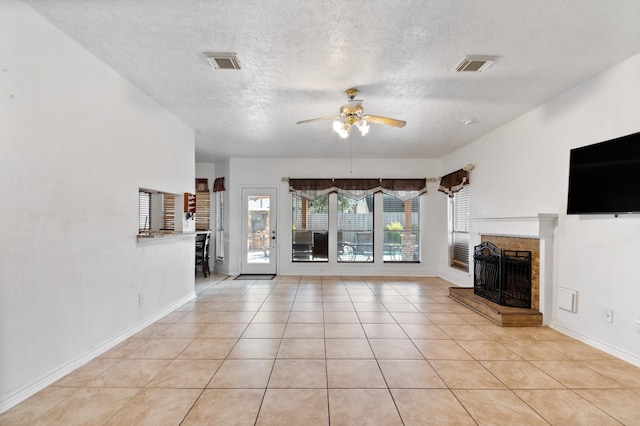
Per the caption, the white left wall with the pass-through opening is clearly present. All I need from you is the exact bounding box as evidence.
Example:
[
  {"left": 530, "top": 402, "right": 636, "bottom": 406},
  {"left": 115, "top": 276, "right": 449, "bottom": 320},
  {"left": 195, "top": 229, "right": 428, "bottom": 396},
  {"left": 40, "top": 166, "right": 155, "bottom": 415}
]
[{"left": 0, "top": 0, "right": 195, "bottom": 411}]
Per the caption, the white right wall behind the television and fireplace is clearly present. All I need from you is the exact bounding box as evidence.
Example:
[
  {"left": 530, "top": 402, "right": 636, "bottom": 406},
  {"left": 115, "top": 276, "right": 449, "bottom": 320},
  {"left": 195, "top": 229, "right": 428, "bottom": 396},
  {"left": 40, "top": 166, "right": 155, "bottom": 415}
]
[{"left": 441, "top": 55, "right": 640, "bottom": 365}]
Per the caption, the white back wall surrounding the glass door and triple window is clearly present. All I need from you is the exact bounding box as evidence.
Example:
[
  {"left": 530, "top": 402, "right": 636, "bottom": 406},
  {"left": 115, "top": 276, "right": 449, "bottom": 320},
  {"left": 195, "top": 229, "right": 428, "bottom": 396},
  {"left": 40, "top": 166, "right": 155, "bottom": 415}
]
[{"left": 225, "top": 156, "right": 446, "bottom": 276}]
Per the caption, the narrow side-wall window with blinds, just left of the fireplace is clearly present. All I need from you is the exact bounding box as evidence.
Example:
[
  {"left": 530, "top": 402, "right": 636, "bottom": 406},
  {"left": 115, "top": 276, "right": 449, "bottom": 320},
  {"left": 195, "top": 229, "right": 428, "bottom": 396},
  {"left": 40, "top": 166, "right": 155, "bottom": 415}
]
[{"left": 448, "top": 185, "right": 470, "bottom": 272}]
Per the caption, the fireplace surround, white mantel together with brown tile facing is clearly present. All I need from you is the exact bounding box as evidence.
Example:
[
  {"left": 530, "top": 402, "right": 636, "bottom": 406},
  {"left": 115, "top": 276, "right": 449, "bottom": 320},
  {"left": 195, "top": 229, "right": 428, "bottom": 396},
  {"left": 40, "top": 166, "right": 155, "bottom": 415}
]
[{"left": 469, "top": 213, "right": 558, "bottom": 324}]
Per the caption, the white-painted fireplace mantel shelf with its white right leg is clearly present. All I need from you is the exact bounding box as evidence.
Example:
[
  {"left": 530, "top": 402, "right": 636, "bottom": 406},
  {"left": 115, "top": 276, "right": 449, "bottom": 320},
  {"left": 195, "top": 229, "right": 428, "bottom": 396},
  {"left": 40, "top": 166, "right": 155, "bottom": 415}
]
[{"left": 469, "top": 213, "right": 558, "bottom": 324}]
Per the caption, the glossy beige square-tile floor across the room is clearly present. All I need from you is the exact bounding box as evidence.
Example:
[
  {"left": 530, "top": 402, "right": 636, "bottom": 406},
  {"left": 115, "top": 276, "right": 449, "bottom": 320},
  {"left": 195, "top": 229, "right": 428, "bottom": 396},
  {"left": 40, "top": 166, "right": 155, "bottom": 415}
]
[{"left": 0, "top": 277, "right": 640, "bottom": 426}]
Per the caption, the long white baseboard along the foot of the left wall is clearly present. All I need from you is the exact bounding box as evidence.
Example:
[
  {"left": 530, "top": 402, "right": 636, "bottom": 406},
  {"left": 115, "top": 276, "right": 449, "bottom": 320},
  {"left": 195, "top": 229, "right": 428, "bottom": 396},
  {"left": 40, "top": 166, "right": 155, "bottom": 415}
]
[{"left": 0, "top": 292, "right": 196, "bottom": 414}]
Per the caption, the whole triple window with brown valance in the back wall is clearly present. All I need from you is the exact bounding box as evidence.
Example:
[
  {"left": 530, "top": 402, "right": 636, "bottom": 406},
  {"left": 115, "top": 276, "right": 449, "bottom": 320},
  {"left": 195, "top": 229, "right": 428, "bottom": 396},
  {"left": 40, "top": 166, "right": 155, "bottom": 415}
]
[{"left": 288, "top": 178, "right": 427, "bottom": 263}]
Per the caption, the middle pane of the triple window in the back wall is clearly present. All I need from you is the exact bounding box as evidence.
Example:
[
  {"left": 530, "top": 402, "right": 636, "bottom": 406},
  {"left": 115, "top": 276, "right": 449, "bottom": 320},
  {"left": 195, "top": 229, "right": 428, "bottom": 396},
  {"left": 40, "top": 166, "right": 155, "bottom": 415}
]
[{"left": 338, "top": 194, "right": 373, "bottom": 262}]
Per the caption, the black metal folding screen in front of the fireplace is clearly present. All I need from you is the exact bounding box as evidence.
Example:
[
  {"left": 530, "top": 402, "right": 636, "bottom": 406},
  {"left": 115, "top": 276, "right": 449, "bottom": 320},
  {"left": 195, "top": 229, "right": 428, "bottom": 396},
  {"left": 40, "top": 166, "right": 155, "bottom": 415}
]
[{"left": 473, "top": 242, "right": 531, "bottom": 309}]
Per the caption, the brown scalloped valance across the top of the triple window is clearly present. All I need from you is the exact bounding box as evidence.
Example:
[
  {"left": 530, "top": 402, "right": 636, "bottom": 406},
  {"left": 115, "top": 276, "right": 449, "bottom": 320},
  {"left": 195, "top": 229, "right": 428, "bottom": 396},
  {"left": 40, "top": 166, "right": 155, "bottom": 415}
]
[{"left": 289, "top": 178, "right": 427, "bottom": 201}]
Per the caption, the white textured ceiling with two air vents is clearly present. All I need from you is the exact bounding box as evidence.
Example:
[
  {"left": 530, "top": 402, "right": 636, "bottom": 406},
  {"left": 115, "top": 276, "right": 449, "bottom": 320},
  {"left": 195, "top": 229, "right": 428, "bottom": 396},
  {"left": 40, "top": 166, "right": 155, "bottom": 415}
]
[{"left": 26, "top": 0, "right": 640, "bottom": 161}]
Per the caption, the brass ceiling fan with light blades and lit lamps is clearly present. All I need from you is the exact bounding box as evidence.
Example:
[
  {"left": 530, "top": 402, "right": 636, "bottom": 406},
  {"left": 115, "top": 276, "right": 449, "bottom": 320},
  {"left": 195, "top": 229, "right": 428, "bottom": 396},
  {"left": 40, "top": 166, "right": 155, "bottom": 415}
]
[{"left": 296, "top": 88, "right": 407, "bottom": 138}]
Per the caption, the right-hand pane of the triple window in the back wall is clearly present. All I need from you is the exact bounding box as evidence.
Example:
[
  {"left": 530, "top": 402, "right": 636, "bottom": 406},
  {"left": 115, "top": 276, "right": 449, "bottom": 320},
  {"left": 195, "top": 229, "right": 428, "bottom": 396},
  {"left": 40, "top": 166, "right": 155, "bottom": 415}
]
[{"left": 382, "top": 194, "right": 420, "bottom": 262}]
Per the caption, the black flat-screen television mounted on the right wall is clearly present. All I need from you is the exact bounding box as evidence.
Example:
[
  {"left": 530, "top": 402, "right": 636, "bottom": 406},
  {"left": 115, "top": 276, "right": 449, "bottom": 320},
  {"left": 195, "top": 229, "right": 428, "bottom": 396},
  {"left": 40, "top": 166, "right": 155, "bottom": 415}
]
[{"left": 567, "top": 132, "right": 640, "bottom": 214}]
